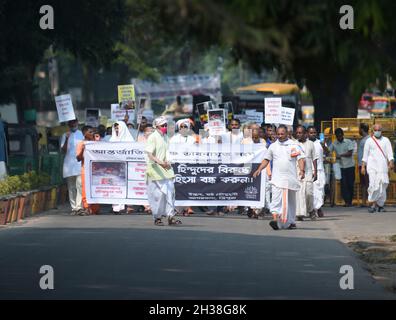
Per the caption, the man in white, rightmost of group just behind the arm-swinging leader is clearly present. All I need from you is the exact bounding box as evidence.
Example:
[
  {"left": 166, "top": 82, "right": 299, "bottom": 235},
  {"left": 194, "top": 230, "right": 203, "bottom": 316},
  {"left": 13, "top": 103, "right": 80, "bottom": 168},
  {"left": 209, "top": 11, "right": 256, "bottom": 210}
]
[{"left": 308, "top": 126, "right": 326, "bottom": 218}]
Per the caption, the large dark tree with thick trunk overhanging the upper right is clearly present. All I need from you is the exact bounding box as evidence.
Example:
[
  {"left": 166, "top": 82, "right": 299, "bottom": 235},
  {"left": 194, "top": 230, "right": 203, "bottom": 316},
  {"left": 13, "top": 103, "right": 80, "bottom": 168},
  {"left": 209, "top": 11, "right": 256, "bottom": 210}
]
[{"left": 154, "top": 0, "right": 396, "bottom": 124}]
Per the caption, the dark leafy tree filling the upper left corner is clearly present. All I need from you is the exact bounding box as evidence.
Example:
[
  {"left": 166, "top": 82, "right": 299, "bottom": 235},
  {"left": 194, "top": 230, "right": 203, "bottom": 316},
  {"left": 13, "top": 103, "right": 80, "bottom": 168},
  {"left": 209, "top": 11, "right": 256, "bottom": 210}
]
[{"left": 0, "top": 0, "right": 125, "bottom": 120}]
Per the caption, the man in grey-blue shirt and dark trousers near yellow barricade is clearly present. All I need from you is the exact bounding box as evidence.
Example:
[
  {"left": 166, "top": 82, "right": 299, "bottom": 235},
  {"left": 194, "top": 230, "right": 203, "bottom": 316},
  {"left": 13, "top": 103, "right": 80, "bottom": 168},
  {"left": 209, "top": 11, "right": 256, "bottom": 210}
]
[{"left": 328, "top": 128, "right": 355, "bottom": 207}]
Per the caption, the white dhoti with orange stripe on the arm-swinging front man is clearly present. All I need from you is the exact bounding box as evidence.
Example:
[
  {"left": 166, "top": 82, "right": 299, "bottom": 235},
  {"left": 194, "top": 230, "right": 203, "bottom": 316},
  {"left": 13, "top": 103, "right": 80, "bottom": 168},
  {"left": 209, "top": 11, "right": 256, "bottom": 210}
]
[{"left": 270, "top": 185, "right": 297, "bottom": 229}]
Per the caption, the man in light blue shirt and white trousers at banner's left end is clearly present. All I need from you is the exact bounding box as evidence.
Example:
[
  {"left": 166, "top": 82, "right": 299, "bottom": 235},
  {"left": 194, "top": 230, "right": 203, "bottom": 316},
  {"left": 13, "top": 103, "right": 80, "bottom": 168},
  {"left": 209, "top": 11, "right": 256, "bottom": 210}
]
[{"left": 61, "top": 119, "right": 84, "bottom": 215}]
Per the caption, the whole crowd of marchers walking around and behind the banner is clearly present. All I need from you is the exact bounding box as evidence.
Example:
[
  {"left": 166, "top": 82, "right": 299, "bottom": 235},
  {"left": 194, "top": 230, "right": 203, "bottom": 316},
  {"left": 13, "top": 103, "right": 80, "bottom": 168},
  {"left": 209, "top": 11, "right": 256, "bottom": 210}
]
[{"left": 61, "top": 116, "right": 393, "bottom": 230}]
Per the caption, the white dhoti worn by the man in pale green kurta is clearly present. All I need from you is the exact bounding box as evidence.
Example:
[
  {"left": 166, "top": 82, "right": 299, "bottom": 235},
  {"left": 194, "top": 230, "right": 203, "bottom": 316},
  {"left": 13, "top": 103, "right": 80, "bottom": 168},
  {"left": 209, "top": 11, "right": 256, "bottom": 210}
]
[{"left": 147, "top": 180, "right": 175, "bottom": 220}]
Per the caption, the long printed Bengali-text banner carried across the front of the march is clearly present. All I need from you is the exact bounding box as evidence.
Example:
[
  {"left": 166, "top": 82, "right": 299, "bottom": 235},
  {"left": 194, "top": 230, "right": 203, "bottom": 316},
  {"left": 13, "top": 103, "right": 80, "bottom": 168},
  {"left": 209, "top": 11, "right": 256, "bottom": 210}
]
[{"left": 84, "top": 142, "right": 265, "bottom": 207}]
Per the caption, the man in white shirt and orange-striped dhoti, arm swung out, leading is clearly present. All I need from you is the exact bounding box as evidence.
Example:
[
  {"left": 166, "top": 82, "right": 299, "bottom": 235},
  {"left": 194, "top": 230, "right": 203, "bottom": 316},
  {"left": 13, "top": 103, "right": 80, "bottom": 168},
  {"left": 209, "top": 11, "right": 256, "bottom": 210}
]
[{"left": 253, "top": 125, "right": 305, "bottom": 230}]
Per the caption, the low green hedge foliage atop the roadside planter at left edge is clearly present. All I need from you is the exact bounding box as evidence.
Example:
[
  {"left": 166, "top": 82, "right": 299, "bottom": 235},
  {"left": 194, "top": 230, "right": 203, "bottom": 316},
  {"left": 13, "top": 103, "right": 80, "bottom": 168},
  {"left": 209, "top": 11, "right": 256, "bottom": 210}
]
[{"left": 0, "top": 171, "right": 51, "bottom": 196}]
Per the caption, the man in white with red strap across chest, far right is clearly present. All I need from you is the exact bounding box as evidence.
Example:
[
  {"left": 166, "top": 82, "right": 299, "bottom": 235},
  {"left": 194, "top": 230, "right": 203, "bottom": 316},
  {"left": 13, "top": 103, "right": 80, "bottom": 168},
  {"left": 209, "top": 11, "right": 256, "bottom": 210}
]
[{"left": 361, "top": 124, "right": 394, "bottom": 213}]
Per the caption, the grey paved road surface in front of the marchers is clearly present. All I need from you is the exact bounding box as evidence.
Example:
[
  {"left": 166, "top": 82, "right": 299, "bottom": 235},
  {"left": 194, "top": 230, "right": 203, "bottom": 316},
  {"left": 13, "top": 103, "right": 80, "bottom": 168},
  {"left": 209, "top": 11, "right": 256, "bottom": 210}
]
[{"left": 0, "top": 209, "right": 396, "bottom": 299}]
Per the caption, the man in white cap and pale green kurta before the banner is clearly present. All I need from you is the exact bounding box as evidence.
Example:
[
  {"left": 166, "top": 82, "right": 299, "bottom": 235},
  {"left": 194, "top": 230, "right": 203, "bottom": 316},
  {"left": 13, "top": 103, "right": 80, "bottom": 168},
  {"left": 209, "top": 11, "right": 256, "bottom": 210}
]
[{"left": 145, "top": 116, "right": 181, "bottom": 226}]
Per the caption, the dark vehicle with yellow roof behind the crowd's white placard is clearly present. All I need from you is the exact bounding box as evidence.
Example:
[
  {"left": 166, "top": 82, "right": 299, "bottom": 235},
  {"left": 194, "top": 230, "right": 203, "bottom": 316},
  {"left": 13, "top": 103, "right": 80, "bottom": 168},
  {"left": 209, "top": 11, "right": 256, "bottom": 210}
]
[{"left": 223, "top": 83, "right": 302, "bottom": 124}]
